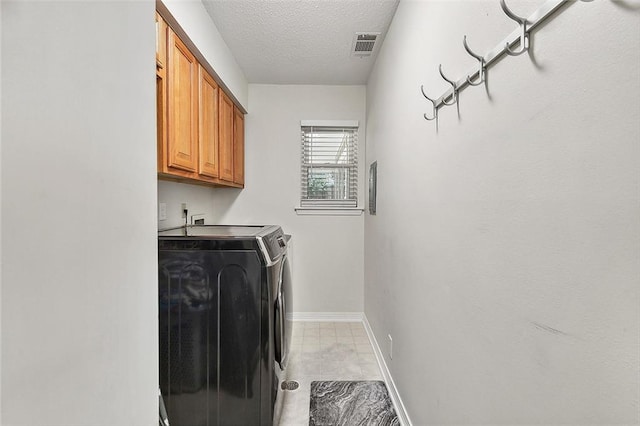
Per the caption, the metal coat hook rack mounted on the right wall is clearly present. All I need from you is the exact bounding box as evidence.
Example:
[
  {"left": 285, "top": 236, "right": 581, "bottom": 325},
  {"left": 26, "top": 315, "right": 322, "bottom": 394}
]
[{"left": 420, "top": 0, "right": 571, "bottom": 122}]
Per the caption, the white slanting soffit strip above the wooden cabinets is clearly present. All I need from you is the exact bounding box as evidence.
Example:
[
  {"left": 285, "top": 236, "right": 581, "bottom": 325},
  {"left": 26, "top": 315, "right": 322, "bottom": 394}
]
[{"left": 163, "top": 0, "right": 248, "bottom": 109}]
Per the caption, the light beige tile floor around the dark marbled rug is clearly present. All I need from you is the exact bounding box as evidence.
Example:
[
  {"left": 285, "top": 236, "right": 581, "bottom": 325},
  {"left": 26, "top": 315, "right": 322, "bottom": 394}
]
[{"left": 280, "top": 321, "right": 383, "bottom": 426}]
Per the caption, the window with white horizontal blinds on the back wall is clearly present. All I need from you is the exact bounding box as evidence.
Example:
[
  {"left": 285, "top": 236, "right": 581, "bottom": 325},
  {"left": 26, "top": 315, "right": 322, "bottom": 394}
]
[{"left": 300, "top": 121, "right": 358, "bottom": 208}]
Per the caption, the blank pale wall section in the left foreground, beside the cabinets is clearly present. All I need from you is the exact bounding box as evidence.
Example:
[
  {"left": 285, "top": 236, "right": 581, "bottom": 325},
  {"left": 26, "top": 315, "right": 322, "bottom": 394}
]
[{"left": 0, "top": 1, "right": 158, "bottom": 426}]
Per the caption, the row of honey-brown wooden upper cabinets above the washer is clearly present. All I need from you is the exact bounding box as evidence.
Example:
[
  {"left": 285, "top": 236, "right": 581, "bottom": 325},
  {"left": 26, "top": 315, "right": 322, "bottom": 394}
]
[{"left": 155, "top": 12, "right": 244, "bottom": 188}]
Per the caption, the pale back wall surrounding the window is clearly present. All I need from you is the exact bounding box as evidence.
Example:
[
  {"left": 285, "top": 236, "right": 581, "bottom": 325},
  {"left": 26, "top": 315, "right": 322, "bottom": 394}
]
[{"left": 214, "top": 84, "right": 366, "bottom": 312}]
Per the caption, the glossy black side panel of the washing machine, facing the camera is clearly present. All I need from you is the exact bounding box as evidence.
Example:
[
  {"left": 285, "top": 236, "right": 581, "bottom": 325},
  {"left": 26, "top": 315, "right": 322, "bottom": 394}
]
[{"left": 158, "top": 250, "right": 268, "bottom": 426}]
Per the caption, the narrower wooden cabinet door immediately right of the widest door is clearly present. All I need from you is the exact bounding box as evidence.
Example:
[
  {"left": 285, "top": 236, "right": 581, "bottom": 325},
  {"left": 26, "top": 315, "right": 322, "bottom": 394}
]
[{"left": 198, "top": 66, "right": 220, "bottom": 178}]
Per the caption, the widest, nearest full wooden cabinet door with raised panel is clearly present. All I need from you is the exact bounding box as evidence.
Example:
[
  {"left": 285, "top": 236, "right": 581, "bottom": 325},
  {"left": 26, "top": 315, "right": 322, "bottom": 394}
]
[{"left": 167, "top": 30, "right": 198, "bottom": 172}]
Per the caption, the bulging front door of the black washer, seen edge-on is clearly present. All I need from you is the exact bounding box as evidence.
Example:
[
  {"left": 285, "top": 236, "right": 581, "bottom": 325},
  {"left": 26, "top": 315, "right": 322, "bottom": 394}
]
[{"left": 274, "top": 252, "right": 292, "bottom": 370}]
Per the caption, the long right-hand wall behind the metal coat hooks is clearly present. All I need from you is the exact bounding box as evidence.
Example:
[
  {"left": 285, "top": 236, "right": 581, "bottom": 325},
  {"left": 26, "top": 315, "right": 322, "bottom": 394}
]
[{"left": 365, "top": 1, "right": 640, "bottom": 425}]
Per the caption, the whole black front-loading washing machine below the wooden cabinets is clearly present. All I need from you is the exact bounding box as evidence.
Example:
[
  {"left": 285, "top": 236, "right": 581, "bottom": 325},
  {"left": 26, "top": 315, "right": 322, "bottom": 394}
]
[{"left": 158, "top": 225, "right": 291, "bottom": 426}]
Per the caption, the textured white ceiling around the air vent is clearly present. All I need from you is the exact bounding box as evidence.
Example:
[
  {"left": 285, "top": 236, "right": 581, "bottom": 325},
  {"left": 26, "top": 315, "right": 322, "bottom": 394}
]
[{"left": 203, "top": 0, "right": 399, "bottom": 85}]
